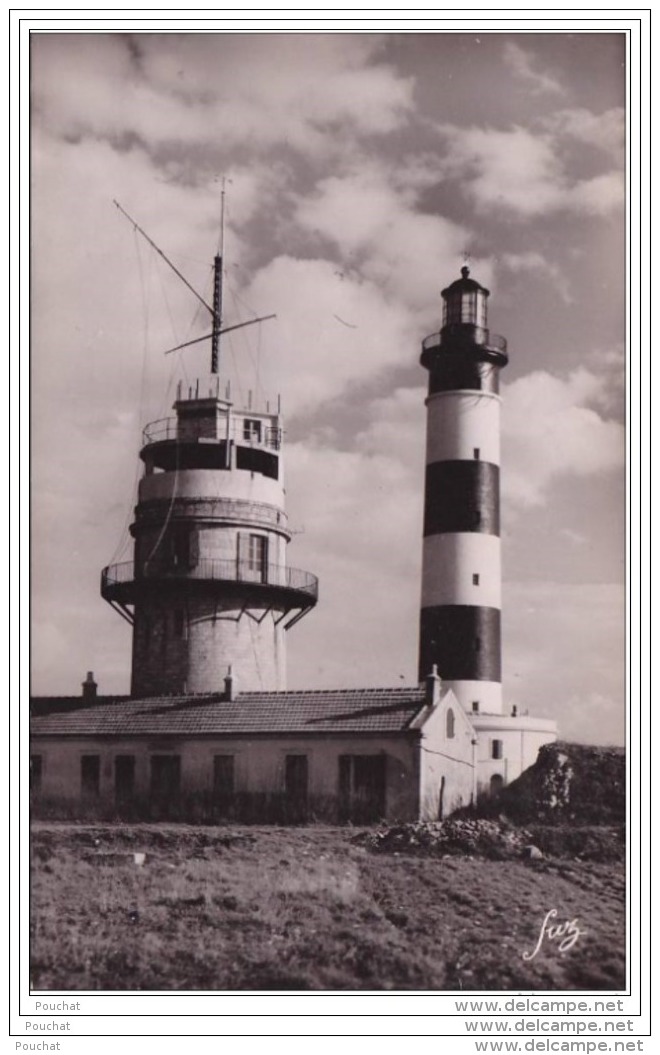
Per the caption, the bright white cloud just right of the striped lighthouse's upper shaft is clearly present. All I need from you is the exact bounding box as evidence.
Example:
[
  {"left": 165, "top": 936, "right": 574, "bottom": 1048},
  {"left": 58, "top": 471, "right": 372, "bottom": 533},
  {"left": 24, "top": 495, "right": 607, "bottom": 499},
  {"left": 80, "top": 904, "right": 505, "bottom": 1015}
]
[{"left": 502, "top": 367, "right": 625, "bottom": 509}]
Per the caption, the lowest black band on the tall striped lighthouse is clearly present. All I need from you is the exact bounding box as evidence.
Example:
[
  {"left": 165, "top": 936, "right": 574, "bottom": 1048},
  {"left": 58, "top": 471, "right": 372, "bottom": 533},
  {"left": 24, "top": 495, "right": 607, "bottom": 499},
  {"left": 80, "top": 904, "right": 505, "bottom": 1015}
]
[{"left": 420, "top": 605, "right": 502, "bottom": 682}]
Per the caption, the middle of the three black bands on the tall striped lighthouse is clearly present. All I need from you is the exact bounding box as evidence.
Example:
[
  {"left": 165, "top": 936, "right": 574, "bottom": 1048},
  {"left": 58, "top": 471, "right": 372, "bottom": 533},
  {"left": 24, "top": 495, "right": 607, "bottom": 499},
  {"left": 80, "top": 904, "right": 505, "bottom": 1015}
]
[{"left": 424, "top": 460, "right": 500, "bottom": 536}]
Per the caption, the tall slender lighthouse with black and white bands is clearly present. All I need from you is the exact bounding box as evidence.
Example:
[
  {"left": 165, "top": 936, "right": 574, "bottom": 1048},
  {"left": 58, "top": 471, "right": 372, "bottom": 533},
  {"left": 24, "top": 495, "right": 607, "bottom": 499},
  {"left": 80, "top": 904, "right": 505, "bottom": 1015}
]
[{"left": 420, "top": 267, "right": 508, "bottom": 714}]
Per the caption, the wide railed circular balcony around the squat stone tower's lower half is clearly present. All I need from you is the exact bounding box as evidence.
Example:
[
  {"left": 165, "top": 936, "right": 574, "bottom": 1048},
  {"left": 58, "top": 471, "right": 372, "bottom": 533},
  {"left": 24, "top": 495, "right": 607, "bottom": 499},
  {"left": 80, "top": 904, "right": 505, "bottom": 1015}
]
[{"left": 101, "top": 559, "right": 318, "bottom": 609}]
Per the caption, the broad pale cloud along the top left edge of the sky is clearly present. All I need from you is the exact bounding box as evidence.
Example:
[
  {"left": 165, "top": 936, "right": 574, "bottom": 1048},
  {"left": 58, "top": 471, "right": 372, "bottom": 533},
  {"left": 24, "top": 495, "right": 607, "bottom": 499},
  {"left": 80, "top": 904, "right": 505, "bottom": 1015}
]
[{"left": 33, "top": 34, "right": 412, "bottom": 165}]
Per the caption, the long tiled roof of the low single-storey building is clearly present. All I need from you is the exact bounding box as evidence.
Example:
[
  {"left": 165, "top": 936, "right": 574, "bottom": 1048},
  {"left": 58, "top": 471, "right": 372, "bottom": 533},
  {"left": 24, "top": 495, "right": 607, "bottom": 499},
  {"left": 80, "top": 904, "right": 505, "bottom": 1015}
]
[{"left": 31, "top": 688, "right": 424, "bottom": 736}]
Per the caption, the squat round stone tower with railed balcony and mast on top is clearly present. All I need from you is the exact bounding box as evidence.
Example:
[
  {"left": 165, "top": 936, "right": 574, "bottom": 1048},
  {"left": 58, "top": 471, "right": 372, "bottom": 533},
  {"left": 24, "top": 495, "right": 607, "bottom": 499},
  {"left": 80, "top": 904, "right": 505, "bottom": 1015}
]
[{"left": 101, "top": 241, "right": 318, "bottom": 696}]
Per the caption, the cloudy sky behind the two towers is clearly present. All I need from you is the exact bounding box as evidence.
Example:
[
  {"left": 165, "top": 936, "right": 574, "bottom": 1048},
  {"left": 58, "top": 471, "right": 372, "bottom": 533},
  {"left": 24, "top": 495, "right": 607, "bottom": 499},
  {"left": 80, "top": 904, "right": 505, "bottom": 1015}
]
[{"left": 31, "top": 32, "right": 625, "bottom": 744}]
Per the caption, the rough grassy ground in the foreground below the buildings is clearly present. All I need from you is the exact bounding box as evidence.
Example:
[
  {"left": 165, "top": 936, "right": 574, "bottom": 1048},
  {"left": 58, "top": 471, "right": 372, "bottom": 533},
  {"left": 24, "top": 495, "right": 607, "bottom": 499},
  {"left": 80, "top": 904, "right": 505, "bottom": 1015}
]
[{"left": 31, "top": 823, "right": 625, "bottom": 991}]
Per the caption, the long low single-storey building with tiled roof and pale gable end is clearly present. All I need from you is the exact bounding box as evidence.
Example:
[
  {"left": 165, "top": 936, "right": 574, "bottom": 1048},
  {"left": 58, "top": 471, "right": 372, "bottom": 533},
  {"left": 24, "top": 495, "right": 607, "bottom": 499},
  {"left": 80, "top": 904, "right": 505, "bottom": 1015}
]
[{"left": 31, "top": 674, "right": 477, "bottom": 824}]
